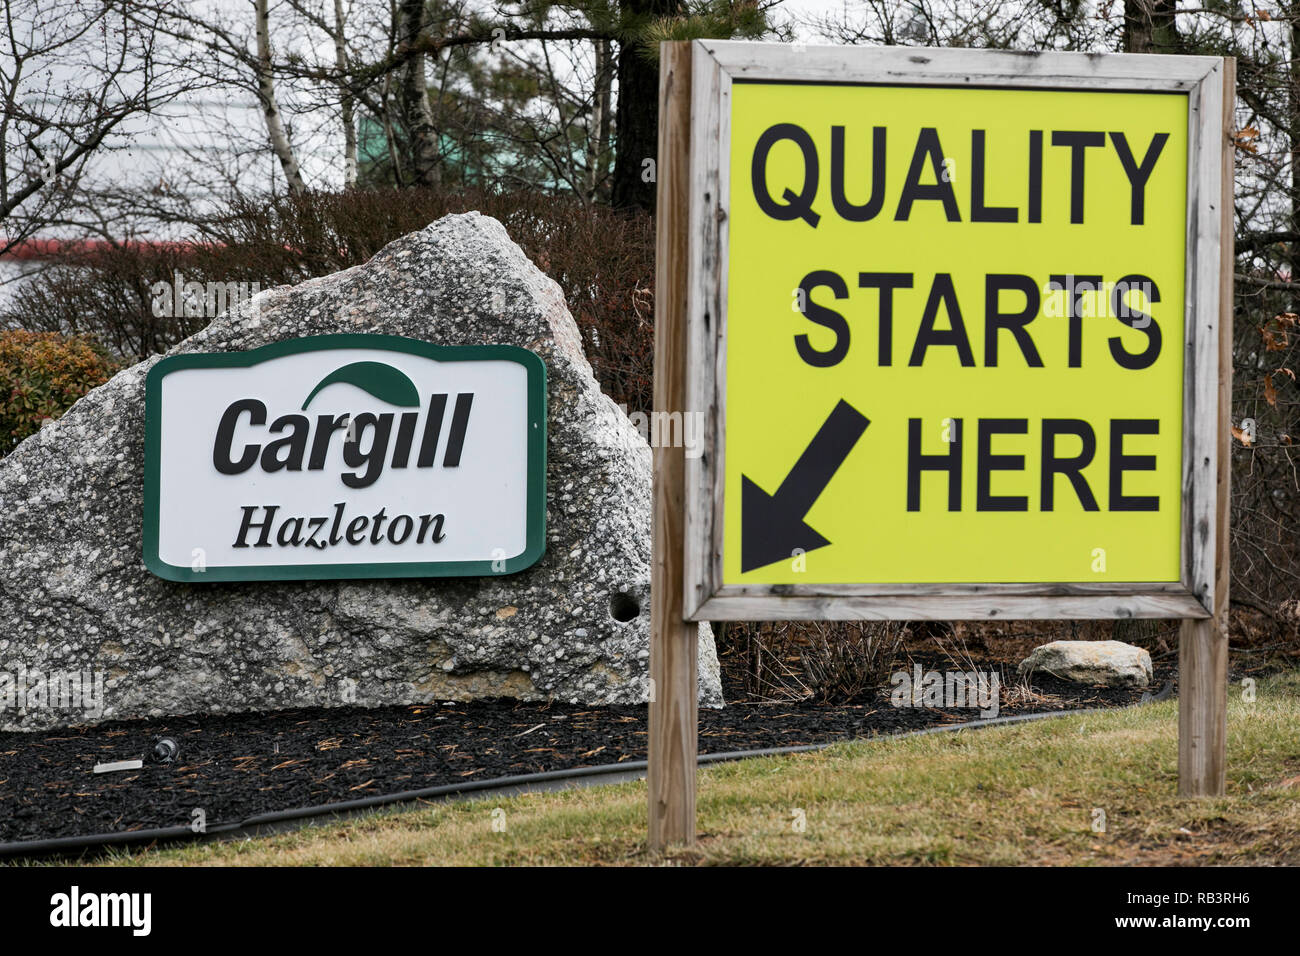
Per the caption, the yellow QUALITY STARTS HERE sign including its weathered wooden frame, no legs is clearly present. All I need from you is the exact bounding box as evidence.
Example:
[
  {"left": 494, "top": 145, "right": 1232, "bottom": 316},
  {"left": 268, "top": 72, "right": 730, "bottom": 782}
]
[{"left": 681, "top": 40, "right": 1234, "bottom": 620}]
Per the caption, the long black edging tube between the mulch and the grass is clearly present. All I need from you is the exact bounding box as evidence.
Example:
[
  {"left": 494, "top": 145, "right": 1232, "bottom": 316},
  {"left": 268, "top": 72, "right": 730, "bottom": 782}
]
[{"left": 0, "top": 700, "right": 1147, "bottom": 857}]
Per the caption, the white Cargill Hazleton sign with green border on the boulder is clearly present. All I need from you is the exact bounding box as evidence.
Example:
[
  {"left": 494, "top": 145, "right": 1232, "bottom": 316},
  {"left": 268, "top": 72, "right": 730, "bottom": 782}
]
[{"left": 144, "top": 336, "right": 546, "bottom": 581}]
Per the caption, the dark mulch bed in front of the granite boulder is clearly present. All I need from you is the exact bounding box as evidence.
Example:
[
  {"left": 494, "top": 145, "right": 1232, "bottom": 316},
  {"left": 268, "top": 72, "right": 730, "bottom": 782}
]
[{"left": 0, "top": 661, "right": 1173, "bottom": 843}]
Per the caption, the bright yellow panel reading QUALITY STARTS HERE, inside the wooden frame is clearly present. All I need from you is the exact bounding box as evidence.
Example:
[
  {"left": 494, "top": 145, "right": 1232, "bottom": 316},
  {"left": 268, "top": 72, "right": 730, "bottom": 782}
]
[{"left": 723, "top": 81, "right": 1188, "bottom": 585}]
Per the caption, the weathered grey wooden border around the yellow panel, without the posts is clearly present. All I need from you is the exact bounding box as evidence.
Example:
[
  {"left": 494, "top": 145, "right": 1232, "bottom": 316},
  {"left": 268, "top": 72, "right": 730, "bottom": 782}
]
[{"left": 684, "top": 40, "right": 1232, "bottom": 629}]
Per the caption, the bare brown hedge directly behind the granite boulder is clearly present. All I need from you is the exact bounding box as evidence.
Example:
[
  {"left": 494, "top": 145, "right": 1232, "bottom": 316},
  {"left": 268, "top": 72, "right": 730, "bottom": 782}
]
[{"left": 0, "top": 189, "right": 654, "bottom": 411}]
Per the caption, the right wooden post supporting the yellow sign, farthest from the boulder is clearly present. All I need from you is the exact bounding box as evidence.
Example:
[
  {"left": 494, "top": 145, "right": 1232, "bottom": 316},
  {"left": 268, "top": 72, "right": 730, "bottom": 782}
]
[{"left": 1178, "top": 59, "right": 1236, "bottom": 796}]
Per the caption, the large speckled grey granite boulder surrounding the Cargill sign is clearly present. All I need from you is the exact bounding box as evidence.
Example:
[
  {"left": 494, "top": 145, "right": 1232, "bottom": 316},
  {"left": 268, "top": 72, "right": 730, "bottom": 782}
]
[{"left": 0, "top": 213, "right": 722, "bottom": 730}]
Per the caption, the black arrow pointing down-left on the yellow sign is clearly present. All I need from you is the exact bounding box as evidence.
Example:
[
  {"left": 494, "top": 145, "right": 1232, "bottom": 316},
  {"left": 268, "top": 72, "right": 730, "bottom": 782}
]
[{"left": 740, "top": 399, "right": 871, "bottom": 574}]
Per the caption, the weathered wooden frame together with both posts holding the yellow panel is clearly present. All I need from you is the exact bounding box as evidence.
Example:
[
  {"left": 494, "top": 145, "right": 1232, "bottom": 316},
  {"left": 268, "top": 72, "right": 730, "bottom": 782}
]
[{"left": 646, "top": 40, "right": 1236, "bottom": 849}]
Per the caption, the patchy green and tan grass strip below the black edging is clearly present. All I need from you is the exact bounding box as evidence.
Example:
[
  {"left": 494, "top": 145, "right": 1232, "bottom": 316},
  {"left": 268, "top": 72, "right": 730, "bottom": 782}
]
[{"left": 27, "top": 674, "right": 1300, "bottom": 866}]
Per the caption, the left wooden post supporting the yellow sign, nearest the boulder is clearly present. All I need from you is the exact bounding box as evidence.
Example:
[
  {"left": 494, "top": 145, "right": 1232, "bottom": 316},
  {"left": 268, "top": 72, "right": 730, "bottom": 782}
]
[{"left": 646, "top": 43, "right": 699, "bottom": 849}]
